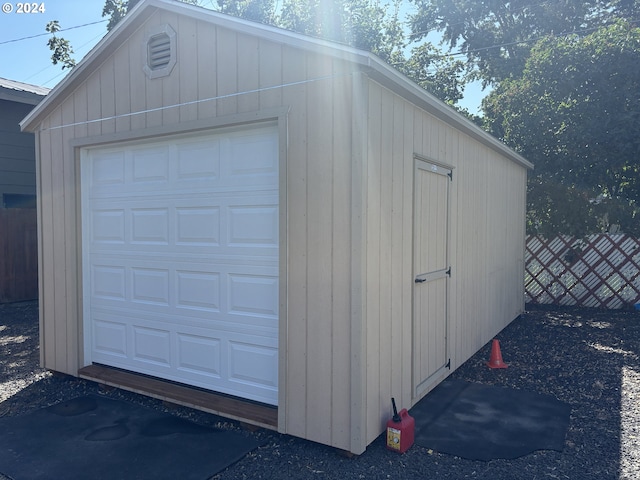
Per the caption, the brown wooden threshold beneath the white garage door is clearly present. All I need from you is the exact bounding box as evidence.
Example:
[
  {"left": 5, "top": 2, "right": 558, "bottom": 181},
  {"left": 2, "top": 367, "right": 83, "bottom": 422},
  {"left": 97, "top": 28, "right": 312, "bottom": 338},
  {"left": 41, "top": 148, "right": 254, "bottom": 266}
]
[{"left": 78, "top": 365, "right": 278, "bottom": 430}]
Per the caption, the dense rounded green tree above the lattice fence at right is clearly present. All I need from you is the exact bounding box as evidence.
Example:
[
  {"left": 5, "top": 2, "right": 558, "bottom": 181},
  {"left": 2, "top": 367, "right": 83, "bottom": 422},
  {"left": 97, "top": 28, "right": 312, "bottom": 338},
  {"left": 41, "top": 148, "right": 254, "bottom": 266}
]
[{"left": 483, "top": 21, "right": 640, "bottom": 235}]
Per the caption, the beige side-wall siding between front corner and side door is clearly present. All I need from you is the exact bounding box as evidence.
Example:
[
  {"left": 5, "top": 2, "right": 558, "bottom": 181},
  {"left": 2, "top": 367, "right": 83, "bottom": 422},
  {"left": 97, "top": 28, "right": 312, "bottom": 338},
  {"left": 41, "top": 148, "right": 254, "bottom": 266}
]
[{"left": 363, "top": 82, "right": 423, "bottom": 444}]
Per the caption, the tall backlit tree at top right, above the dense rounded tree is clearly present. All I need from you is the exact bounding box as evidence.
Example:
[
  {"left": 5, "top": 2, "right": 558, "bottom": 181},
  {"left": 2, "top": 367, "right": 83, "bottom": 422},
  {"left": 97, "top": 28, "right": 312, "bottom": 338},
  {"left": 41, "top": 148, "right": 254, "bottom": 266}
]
[{"left": 410, "top": 0, "right": 612, "bottom": 86}]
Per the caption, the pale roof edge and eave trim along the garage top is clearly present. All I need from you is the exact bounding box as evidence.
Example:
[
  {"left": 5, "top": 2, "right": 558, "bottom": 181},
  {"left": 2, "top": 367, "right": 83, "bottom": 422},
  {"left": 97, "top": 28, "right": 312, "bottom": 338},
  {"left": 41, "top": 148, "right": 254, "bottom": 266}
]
[{"left": 20, "top": 0, "right": 533, "bottom": 168}]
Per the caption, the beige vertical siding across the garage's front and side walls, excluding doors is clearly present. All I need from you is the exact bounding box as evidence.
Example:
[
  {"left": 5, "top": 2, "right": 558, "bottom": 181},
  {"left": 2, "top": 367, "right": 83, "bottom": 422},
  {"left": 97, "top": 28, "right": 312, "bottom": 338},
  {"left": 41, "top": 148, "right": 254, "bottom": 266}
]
[{"left": 32, "top": 10, "right": 526, "bottom": 453}]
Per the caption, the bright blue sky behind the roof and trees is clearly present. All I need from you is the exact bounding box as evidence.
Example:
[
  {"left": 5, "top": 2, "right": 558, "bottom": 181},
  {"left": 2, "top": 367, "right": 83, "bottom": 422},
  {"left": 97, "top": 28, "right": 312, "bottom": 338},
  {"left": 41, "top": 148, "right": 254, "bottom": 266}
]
[{"left": 0, "top": 0, "right": 486, "bottom": 113}]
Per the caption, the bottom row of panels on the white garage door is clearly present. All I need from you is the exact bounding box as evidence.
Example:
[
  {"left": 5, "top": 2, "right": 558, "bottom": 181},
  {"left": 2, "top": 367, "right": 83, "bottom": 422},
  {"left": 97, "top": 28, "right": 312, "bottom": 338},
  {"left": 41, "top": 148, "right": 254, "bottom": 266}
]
[{"left": 93, "top": 314, "right": 278, "bottom": 403}]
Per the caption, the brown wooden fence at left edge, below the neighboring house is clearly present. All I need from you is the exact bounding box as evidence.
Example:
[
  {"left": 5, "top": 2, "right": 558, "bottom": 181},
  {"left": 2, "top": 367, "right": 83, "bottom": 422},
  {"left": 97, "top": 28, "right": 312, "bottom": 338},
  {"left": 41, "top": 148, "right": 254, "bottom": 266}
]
[{"left": 0, "top": 208, "right": 38, "bottom": 303}]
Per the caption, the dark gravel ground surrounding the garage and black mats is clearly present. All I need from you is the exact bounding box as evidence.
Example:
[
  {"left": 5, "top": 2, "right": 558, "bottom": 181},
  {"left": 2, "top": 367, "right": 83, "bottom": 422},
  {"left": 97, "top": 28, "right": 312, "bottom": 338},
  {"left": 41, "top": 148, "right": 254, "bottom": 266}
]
[{"left": 0, "top": 302, "right": 640, "bottom": 480}]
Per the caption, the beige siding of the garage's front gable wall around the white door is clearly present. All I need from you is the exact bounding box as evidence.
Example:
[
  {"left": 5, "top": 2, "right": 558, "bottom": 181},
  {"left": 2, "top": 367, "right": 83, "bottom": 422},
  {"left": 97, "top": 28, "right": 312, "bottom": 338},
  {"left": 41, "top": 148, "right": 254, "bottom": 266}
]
[{"left": 35, "top": 12, "right": 360, "bottom": 450}]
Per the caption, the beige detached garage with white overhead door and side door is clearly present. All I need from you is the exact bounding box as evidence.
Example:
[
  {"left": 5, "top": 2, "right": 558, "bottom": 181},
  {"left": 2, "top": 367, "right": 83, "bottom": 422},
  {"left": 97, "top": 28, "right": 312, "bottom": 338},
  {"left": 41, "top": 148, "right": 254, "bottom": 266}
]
[{"left": 22, "top": 0, "right": 531, "bottom": 453}]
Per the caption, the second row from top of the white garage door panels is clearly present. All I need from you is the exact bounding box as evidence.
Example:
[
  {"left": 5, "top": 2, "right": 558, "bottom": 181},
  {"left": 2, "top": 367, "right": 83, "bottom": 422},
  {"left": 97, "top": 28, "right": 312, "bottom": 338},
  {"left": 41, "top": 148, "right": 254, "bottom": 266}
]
[{"left": 90, "top": 195, "right": 279, "bottom": 256}]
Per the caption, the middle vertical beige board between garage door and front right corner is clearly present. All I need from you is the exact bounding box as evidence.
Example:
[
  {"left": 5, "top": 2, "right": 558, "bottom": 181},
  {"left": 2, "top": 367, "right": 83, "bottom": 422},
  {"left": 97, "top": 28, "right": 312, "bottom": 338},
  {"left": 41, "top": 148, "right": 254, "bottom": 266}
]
[{"left": 306, "top": 53, "right": 333, "bottom": 444}]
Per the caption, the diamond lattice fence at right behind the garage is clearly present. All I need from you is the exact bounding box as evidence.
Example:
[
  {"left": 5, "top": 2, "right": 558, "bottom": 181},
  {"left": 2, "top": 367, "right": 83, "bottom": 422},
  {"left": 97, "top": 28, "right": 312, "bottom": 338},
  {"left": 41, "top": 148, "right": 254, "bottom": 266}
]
[{"left": 525, "top": 234, "right": 640, "bottom": 309}]
